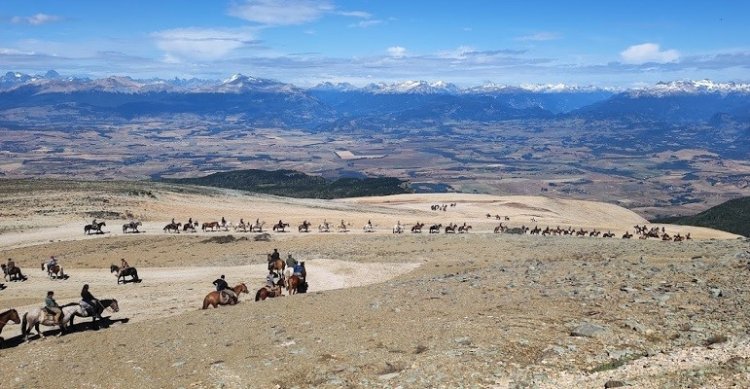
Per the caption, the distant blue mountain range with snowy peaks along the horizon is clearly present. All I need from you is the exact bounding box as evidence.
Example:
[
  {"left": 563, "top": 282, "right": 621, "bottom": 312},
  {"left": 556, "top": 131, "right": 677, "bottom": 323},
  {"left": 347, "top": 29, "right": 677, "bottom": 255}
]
[{"left": 0, "top": 70, "right": 750, "bottom": 131}]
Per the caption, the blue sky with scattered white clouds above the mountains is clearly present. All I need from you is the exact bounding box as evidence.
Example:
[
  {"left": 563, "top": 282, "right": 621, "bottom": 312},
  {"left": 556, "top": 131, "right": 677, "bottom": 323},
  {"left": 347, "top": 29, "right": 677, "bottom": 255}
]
[{"left": 0, "top": 0, "right": 750, "bottom": 87}]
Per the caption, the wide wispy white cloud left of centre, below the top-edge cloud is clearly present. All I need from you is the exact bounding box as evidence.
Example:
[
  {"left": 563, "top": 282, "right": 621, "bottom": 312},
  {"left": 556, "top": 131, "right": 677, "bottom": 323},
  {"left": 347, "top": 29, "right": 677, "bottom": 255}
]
[{"left": 151, "top": 28, "right": 253, "bottom": 62}]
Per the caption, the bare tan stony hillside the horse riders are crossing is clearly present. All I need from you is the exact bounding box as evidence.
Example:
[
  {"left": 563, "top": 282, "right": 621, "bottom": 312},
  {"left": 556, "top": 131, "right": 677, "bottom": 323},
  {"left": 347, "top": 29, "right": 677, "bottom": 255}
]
[{"left": 0, "top": 180, "right": 750, "bottom": 388}]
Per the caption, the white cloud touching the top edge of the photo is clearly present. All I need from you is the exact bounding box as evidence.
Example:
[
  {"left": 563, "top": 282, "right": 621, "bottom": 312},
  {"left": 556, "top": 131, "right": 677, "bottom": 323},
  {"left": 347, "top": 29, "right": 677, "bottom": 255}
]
[{"left": 229, "top": 0, "right": 333, "bottom": 26}]
